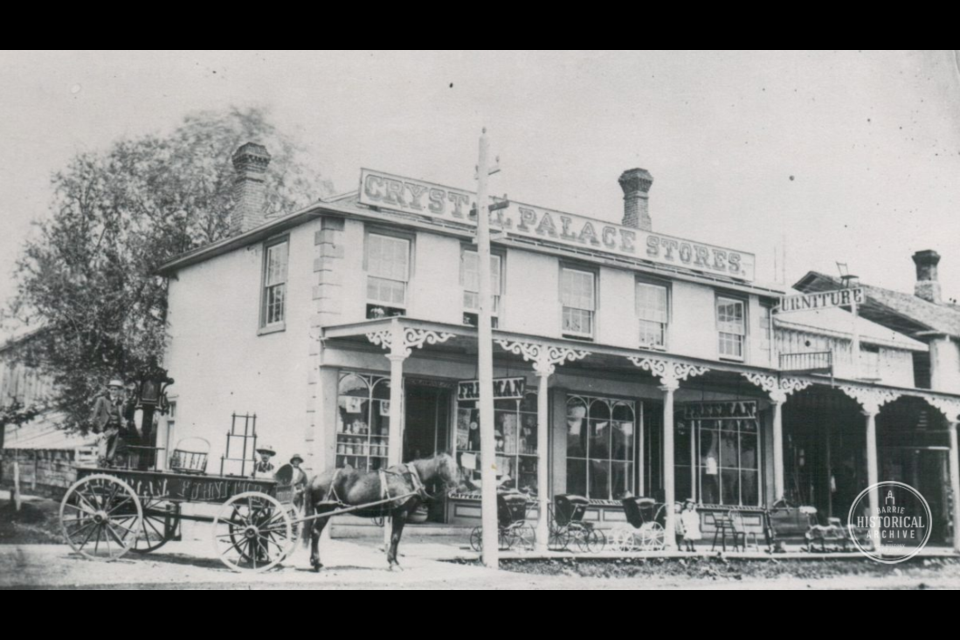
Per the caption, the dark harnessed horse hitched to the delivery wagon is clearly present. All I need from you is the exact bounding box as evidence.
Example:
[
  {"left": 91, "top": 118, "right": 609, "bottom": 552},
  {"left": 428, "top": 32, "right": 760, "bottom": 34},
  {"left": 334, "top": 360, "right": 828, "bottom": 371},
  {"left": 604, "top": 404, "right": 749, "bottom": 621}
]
[{"left": 304, "top": 453, "right": 460, "bottom": 571}]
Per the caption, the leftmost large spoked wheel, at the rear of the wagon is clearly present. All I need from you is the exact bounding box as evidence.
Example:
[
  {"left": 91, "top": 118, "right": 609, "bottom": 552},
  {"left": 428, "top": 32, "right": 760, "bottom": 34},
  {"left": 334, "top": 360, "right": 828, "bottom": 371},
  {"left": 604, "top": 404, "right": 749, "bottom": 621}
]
[{"left": 60, "top": 474, "right": 143, "bottom": 562}]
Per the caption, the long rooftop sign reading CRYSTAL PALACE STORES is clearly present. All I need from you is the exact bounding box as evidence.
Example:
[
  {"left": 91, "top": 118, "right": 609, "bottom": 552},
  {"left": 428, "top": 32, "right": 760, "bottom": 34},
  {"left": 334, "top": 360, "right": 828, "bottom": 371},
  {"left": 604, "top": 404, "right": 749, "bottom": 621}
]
[{"left": 360, "top": 169, "right": 755, "bottom": 282}]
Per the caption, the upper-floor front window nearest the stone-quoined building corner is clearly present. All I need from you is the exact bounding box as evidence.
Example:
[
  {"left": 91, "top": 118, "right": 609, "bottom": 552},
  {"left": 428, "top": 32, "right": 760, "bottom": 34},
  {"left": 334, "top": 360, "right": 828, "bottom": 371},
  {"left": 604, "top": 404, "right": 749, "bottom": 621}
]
[{"left": 367, "top": 233, "right": 410, "bottom": 317}]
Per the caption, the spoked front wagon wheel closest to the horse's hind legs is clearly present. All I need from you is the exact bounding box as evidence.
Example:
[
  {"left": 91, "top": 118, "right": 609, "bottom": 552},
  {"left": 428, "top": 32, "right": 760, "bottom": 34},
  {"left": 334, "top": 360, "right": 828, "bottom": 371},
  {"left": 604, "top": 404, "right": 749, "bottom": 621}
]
[{"left": 213, "top": 491, "right": 297, "bottom": 572}]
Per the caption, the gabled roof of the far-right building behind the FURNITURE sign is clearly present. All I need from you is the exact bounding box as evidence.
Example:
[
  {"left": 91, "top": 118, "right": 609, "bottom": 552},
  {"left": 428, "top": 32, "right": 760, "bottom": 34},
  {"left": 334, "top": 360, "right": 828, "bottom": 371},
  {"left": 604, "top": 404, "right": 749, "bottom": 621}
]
[{"left": 794, "top": 271, "right": 960, "bottom": 340}]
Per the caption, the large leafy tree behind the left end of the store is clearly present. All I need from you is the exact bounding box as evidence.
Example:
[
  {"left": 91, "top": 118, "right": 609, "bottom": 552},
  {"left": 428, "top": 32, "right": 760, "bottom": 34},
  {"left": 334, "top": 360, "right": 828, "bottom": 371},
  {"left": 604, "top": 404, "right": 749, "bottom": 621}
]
[{"left": 12, "top": 108, "right": 331, "bottom": 431}]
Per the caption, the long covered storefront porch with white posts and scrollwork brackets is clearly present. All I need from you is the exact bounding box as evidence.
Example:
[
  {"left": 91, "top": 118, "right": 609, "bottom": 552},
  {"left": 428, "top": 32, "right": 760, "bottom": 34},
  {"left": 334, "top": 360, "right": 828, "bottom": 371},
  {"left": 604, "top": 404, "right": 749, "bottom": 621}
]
[{"left": 316, "top": 318, "right": 960, "bottom": 551}]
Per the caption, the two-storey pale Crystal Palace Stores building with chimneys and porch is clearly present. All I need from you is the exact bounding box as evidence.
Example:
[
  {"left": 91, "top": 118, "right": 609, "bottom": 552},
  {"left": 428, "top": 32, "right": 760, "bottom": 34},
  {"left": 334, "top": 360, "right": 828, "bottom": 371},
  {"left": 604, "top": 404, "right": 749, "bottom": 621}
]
[{"left": 161, "top": 145, "right": 960, "bottom": 552}]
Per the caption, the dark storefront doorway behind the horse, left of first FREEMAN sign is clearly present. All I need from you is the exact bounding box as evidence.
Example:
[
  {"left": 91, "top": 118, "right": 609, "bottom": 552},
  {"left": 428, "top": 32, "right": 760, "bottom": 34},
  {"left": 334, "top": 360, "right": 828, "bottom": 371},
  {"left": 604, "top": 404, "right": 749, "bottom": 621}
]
[{"left": 403, "top": 381, "right": 452, "bottom": 522}]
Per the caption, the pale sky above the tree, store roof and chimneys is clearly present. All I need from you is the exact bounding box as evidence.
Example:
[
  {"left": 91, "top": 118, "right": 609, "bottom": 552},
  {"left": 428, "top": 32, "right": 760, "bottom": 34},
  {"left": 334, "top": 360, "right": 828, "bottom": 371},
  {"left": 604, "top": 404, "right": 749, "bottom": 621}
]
[{"left": 0, "top": 51, "right": 960, "bottom": 338}]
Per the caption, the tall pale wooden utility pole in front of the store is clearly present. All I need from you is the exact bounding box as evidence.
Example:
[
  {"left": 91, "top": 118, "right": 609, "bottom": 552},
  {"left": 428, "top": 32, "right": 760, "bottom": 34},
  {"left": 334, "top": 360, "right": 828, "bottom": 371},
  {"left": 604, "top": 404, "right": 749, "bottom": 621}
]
[{"left": 477, "top": 128, "right": 498, "bottom": 569}]
